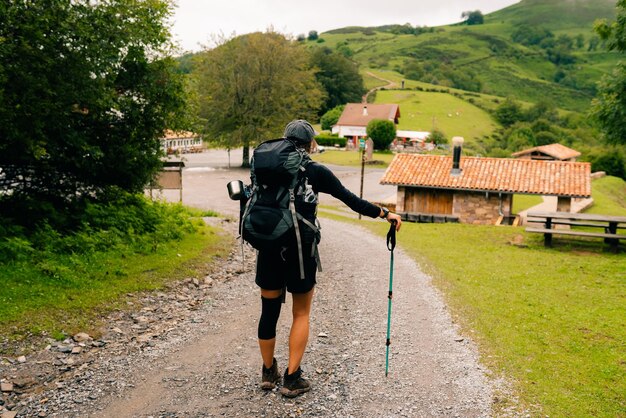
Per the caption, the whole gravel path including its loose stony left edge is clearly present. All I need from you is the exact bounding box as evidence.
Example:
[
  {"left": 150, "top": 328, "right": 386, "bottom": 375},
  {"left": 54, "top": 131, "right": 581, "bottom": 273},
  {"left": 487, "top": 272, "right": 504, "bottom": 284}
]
[{"left": 0, "top": 153, "right": 504, "bottom": 418}]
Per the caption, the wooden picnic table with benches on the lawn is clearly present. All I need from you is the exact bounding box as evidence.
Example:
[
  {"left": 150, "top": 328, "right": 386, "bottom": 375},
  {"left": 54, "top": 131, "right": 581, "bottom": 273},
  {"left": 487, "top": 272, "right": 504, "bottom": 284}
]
[{"left": 526, "top": 212, "right": 626, "bottom": 252}]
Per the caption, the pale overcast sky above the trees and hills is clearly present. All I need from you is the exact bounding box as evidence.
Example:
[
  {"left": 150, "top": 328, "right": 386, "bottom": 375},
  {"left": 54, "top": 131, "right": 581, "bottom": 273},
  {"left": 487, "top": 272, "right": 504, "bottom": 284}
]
[{"left": 172, "top": 0, "right": 519, "bottom": 51}]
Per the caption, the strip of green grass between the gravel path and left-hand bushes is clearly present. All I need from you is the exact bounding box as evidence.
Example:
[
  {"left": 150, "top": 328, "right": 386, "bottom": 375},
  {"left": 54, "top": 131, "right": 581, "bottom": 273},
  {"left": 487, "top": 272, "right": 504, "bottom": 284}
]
[{"left": 0, "top": 221, "right": 231, "bottom": 340}]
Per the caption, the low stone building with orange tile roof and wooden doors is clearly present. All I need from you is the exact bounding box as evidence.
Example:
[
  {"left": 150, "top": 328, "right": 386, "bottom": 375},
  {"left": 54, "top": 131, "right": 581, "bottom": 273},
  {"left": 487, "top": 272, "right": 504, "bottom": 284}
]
[{"left": 380, "top": 140, "right": 591, "bottom": 224}]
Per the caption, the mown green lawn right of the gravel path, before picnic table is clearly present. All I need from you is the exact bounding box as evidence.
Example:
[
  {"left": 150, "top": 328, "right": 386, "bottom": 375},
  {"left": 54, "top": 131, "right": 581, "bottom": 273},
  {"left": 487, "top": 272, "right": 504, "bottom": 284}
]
[{"left": 316, "top": 214, "right": 626, "bottom": 417}]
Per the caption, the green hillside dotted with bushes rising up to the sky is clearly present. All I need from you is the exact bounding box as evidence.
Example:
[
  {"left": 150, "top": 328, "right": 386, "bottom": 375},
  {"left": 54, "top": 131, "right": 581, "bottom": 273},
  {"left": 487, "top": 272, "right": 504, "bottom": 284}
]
[{"left": 314, "top": 0, "right": 619, "bottom": 111}]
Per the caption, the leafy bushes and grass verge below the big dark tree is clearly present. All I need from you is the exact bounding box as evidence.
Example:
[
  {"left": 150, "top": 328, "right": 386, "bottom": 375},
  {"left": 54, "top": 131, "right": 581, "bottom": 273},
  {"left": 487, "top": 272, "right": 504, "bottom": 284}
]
[{"left": 0, "top": 195, "right": 231, "bottom": 346}]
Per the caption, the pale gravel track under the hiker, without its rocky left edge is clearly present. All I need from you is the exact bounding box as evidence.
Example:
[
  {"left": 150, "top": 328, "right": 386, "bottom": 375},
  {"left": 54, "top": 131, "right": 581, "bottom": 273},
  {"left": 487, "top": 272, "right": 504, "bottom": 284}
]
[{"left": 93, "top": 220, "right": 492, "bottom": 417}]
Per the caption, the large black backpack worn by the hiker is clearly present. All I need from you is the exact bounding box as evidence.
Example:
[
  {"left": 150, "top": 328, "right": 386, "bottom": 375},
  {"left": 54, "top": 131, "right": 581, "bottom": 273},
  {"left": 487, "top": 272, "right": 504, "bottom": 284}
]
[{"left": 240, "top": 138, "right": 321, "bottom": 279}]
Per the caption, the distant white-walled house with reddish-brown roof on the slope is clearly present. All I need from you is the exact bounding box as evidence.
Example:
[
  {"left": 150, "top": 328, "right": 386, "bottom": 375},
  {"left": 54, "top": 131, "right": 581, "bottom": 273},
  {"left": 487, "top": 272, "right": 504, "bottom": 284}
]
[{"left": 332, "top": 103, "right": 400, "bottom": 148}]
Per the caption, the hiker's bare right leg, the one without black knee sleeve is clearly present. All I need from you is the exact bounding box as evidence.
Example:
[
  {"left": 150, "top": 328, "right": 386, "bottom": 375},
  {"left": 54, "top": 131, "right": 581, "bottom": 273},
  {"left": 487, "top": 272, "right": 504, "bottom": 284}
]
[{"left": 288, "top": 289, "right": 314, "bottom": 374}]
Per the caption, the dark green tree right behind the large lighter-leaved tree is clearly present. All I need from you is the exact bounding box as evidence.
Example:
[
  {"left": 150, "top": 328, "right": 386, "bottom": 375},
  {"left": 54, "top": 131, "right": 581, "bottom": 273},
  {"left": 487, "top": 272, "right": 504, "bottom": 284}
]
[{"left": 311, "top": 47, "right": 366, "bottom": 115}]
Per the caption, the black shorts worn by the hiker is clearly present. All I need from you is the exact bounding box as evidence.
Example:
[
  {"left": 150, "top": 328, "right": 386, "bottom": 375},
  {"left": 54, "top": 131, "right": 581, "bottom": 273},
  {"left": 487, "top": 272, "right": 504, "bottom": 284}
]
[{"left": 255, "top": 245, "right": 317, "bottom": 293}]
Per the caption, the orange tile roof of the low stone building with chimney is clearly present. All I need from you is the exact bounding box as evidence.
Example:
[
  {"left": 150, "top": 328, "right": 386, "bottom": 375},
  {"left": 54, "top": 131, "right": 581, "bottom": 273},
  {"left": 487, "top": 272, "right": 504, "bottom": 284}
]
[{"left": 380, "top": 154, "right": 591, "bottom": 197}]
